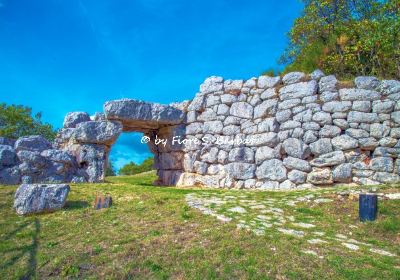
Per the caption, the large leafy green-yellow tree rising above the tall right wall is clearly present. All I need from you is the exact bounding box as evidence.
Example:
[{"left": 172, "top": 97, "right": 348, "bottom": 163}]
[{"left": 280, "top": 0, "right": 400, "bottom": 79}]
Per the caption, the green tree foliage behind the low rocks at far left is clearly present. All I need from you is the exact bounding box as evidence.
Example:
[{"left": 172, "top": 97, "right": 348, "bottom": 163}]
[{"left": 0, "top": 103, "right": 56, "bottom": 140}]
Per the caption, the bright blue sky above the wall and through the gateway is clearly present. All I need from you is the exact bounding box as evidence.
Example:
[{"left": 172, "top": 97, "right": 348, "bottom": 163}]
[{"left": 0, "top": 0, "right": 302, "bottom": 170}]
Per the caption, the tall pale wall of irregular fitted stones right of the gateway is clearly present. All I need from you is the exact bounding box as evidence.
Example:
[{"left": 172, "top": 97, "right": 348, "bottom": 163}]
[{"left": 178, "top": 71, "right": 400, "bottom": 189}]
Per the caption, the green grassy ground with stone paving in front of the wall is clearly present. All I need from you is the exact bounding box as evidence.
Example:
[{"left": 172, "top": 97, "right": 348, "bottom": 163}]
[{"left": 0, "top": 173, "right": 400, "bottom": 279}]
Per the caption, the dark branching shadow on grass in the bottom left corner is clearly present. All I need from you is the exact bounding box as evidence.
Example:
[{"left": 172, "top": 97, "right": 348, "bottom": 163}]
[{"left": 0, "top": 218, "right": 40, "bottom": 279}]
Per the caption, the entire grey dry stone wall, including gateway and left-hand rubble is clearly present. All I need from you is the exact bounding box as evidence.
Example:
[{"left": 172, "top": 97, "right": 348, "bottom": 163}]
[{"left": 0, "top": 70, "right": 400, "bottom": 189}]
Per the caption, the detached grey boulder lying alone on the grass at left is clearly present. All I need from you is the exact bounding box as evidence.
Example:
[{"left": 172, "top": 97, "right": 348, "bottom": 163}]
[{"left": 14, "top": 184, "right": 70, "bottom": 215}]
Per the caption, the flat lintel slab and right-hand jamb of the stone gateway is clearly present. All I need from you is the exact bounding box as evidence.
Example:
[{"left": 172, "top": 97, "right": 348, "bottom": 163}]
[{"left": 104, "top": 99, "right": 185, "bottom": 185}]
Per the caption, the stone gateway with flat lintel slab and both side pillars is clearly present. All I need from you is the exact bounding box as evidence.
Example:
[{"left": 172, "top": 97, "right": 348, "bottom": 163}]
[{"left": 54, "top": 99, "right": 186, "bottom": 185}]
